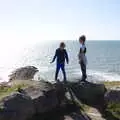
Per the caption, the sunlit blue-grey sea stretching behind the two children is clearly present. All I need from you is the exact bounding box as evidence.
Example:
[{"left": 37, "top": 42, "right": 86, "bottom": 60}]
[{"left": 0, "top": 40, "right": 120, "bottom": 82}]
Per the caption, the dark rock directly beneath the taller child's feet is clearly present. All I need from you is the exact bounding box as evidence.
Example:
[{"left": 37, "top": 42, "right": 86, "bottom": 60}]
[{"left": 69, "top": 82, "right": 106, "bottom": 105}]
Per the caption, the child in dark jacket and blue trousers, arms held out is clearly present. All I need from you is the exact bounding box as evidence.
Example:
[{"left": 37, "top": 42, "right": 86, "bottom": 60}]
[{"left": 51, "top": 42, "right": 69, "bottom": 82}]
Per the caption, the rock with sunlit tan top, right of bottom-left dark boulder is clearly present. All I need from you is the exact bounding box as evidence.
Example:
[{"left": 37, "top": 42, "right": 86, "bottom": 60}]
[{"left": 24, "top": 81, "right": 58, "bottom": 113}]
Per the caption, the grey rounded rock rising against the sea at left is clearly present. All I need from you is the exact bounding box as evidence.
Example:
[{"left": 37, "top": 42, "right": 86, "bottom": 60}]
[{"left": 9, "top": 66, "right": 38, "bottom": 80}]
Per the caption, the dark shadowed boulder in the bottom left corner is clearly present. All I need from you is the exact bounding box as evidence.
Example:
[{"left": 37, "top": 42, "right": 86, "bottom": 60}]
[{"left": 0, "top": 93, "right": 35, "bottom": 120}]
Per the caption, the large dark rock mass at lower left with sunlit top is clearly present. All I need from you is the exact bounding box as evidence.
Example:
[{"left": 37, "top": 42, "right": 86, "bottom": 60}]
[{"left": 0, "top": 81, "right": 60, "bottom": 120}]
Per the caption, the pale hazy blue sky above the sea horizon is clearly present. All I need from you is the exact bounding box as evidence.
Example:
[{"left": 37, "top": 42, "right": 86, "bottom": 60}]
[{"left": 0, "top": 0, "right": 120, "bottom": 44}]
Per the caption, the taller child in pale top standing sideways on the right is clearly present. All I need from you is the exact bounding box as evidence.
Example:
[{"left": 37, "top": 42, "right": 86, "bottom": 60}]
[{"left": 78, "top": 35, "right": 87, "bottom": 82}]
